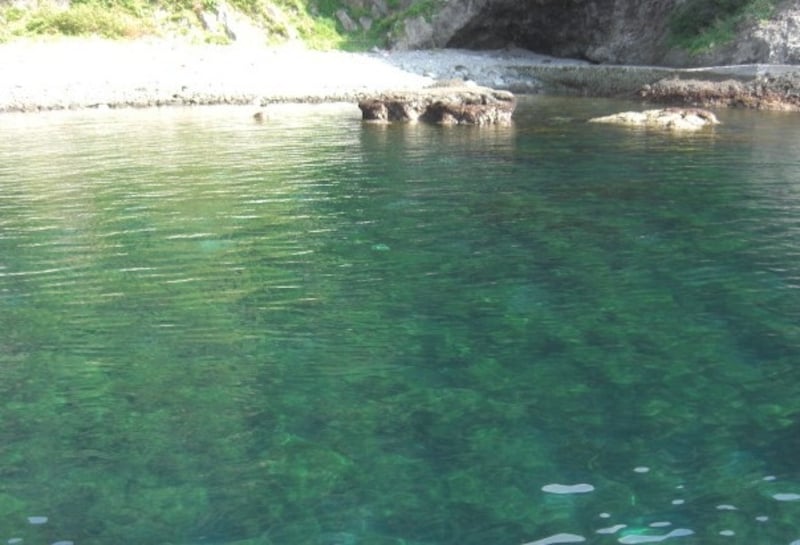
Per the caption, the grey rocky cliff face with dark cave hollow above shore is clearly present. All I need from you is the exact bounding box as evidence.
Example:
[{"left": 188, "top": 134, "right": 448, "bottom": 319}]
[{"left": 392, "top": 0, "right": 800, "bottom": 66}]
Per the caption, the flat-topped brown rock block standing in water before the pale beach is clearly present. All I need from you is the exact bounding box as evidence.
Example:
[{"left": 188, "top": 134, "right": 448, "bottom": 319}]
[{"left": 358, "top": 82, "right": 516, "bottom": 125}]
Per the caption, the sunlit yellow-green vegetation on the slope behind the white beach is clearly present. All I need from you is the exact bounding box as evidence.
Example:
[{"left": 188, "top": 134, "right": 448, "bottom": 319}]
[{"left": 0, "top": 0, "right": 433, "bottom": 50}]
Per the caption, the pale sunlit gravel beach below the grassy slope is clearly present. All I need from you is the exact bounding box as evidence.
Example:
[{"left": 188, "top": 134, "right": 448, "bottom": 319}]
[{"left": 0, "top": 38, "right": 579, "bottom": 112}]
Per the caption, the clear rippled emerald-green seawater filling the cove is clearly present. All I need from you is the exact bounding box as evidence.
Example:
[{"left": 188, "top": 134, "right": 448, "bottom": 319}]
[{"left": 0, "top": 98, "right": 800, "bottom": 545}]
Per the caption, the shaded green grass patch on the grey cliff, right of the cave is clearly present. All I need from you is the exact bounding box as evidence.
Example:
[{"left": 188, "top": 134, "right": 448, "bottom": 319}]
[{"left": 669, "top": 0, "right": 776, "bottom": 54}]
